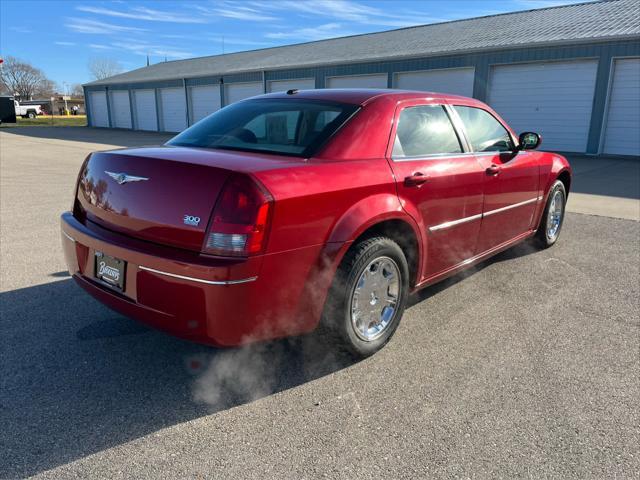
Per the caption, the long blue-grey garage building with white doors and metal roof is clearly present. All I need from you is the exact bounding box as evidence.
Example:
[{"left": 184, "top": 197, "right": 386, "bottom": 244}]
[{"left": 85, "top": 0, "right": 640, "bottom": 156}]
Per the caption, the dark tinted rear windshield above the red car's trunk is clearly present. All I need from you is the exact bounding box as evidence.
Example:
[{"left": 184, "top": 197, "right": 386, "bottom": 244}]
[{"left": 168, "top": 99, "right": 358, "bottom": 157}]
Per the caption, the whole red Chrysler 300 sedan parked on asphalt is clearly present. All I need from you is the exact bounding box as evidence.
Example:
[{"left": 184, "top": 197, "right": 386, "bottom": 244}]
[{"left": 62, "top": 90, "right": 571, "bottom": 355}]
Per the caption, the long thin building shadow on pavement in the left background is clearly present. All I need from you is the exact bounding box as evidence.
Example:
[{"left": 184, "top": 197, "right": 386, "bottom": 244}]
[{"left": 0, "top": 126, "right": 175, "bottom": 147}]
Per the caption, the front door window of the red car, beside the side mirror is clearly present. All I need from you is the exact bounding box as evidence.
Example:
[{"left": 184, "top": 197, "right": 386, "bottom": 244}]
[{"left": 453, "top": 105, "right": 513, "bottom": 152}]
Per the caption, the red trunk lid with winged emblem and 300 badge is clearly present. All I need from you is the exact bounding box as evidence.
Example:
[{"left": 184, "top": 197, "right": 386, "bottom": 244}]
[{"left": 77, "top": 149, "right": 231, "bottom": 251}]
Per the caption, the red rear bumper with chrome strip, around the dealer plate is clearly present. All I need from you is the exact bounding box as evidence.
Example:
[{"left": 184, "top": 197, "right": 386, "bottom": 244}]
[{"left": 61, "top": 212, "right": 328, "bottom": 346}]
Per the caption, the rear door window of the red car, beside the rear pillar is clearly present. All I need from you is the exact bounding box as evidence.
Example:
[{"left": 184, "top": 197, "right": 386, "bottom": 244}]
[{"left": 393, "top": 105, "right": 462, "bottom": 159}]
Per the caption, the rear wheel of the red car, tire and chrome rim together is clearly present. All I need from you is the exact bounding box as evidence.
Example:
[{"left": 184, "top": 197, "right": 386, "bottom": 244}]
[{"left": 322, "top": 237, "right": 409, "bottom": 357}]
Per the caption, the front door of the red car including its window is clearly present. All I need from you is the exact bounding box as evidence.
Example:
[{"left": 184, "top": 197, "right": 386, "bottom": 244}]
[{"left": 452, "top": 105, "right": 540, "bottom": 254}]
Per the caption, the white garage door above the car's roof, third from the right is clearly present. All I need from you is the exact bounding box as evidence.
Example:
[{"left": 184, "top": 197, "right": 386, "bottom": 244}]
[{"left": 394, "top": 68, "right": 475, "bottom": 97}]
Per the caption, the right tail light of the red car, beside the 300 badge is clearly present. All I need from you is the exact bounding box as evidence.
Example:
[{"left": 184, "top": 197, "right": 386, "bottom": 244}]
[{"left": 203, "top": 175, "right": 273, "bottom": 257}]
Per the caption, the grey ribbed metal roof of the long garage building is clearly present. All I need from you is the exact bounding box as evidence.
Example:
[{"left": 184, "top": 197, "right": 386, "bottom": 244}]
[{"left": 87, "top": 0, "right": 640, "bottom": 85}]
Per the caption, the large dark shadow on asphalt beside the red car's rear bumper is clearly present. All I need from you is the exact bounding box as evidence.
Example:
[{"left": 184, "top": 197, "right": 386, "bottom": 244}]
[{"left": 0, "top": 279, "right": 355, "bottom": 478}]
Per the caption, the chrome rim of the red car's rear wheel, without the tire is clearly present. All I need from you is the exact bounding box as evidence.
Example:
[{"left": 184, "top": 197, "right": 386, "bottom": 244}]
[{"left": 350, "top": 257, "right": 402, "bottom": 342}]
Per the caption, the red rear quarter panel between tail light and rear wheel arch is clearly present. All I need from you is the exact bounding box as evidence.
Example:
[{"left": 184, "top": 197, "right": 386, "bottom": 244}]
[{"left": 254, "top": 158, "right": 406, "bottom": 331}]
